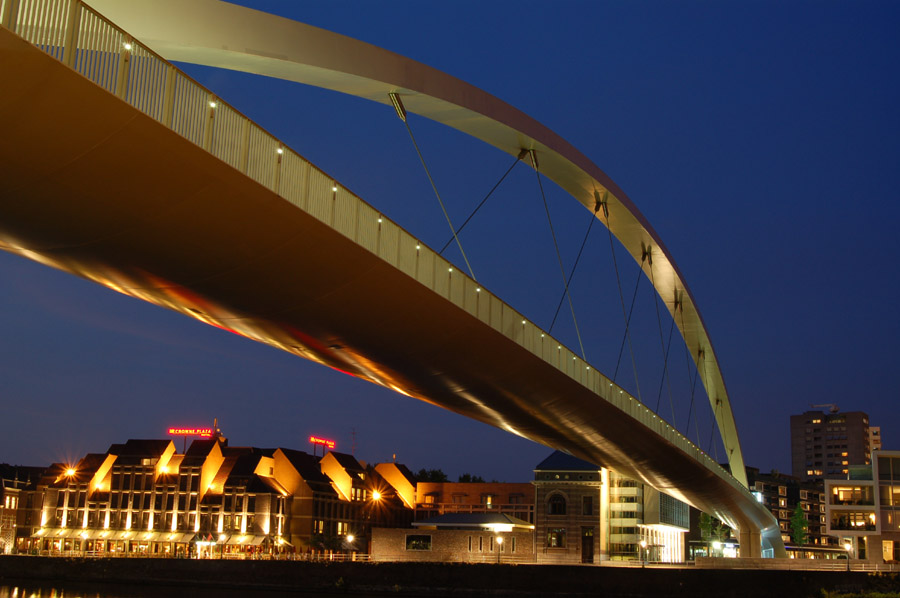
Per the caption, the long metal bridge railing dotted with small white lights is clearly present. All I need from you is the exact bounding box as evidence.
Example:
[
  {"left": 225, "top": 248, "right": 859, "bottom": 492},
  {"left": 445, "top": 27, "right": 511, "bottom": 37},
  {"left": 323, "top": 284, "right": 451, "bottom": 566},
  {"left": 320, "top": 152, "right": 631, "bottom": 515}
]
[{"left": 0, "top": 0, "right": 743, "bottom": 500}]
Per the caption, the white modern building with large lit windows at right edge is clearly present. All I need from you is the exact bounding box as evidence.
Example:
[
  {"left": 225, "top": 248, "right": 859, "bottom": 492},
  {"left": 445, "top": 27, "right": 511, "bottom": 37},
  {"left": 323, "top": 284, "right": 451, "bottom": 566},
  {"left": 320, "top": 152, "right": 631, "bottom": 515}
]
[{"left": 825, "top": 451, "right": 900, "bottom": 563}]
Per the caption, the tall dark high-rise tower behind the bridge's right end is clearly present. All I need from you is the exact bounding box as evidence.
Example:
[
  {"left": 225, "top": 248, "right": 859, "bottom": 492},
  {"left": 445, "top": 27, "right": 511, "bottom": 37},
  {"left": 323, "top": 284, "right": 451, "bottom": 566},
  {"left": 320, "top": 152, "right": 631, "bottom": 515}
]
[{"left": 791, "top": 406, "right": 872, "bottom": 481}]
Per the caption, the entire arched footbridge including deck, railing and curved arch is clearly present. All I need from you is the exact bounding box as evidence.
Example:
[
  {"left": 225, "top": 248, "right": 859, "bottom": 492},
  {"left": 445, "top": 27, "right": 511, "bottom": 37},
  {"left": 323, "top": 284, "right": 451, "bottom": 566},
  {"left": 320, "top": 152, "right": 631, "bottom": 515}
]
[{"left": 0, "top": 0, "right": 784, "bottom": 556}]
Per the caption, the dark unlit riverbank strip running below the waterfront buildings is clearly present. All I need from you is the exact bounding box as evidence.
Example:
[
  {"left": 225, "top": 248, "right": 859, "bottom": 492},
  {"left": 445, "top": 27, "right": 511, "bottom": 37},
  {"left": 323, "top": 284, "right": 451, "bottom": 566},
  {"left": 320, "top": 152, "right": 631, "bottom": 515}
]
[{"left": 0, "top": 556, "right": 900, "bottom": 598}]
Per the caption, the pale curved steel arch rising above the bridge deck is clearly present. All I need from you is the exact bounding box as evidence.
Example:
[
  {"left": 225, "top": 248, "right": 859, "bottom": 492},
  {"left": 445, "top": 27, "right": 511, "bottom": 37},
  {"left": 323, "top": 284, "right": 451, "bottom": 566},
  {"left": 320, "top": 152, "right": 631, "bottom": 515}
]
[{"left": 84, "top": 0, "right": 747, "bottom": 486}]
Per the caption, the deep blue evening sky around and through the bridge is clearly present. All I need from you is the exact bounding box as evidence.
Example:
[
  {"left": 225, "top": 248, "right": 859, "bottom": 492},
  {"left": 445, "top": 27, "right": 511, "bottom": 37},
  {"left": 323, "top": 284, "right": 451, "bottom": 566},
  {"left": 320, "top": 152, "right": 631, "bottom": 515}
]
[{"left": 0, "top": 0, "right": 900, "bottom": 481}]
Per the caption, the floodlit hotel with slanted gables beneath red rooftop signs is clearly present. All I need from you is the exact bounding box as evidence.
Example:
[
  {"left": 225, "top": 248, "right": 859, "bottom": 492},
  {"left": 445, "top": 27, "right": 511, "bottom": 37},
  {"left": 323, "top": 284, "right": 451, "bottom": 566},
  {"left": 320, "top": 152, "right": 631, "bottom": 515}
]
[{"left": 16, "top": 438, "right": 411, "bottom": 558}]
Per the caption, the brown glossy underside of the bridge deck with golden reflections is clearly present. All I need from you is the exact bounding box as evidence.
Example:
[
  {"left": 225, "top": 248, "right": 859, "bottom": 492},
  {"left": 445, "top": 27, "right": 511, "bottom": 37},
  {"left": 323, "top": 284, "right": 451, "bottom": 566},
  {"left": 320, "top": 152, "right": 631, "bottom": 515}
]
[{"left": 0, "top": 23, "right": 780, "bottom": 554}]
